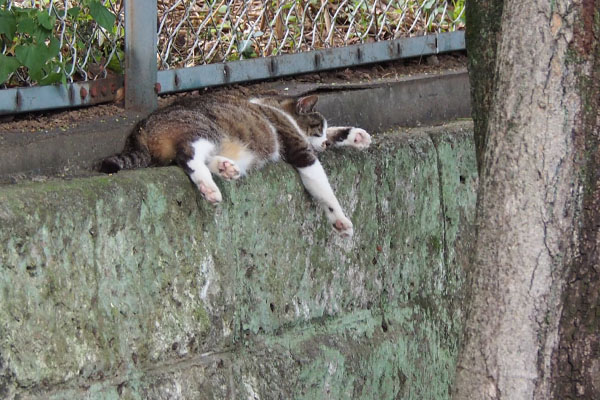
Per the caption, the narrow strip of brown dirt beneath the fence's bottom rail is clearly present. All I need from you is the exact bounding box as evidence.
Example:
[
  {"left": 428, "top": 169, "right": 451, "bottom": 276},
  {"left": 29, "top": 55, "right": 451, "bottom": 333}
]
[{"left": 0, "top": 53, "right": 467, "bottom": 133}]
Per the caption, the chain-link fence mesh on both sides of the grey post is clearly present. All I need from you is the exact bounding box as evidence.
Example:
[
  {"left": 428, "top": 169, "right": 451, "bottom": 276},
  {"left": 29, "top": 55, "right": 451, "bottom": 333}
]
[{"left": 0, "top": 0, "right": 464, "bottom": 87}]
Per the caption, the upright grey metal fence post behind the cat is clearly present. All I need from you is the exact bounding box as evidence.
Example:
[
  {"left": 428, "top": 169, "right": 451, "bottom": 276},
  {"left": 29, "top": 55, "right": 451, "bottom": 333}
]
[{"left": 125, "top": 0, "right": 158, "bottom": 111}]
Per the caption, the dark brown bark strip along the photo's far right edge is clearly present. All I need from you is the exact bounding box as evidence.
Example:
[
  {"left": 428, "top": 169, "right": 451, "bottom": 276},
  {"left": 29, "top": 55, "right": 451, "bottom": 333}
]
[{"left": 552, "top": 0, "right": 600, "bottom": 399}]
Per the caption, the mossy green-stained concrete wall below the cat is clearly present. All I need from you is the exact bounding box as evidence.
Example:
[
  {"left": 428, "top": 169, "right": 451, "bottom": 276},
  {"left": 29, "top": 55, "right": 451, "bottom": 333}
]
[{"left": 0, "top": 122, "right": 477, "bottom": 400}]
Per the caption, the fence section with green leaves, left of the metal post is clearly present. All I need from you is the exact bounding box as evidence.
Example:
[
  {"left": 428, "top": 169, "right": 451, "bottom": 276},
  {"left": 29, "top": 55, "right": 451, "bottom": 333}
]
[{"left": 0, "top": 0, "right": 125, "bottom": 87}]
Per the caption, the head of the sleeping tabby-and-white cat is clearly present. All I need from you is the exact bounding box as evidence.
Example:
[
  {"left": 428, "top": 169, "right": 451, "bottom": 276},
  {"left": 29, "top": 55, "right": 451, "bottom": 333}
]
[{"left": 293, "top": 95, "right": 327, "bottom": 151}]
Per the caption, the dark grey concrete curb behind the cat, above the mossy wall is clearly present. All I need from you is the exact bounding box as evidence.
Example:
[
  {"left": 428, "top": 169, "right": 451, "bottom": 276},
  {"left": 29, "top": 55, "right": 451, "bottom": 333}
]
[{"left": 0, "top": 71, "right": 470, "bottom": 183}]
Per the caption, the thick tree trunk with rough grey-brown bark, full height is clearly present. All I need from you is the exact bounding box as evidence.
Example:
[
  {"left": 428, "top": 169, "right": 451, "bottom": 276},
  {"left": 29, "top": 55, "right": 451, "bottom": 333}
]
[{"left": 453, "top": 0, "right": 600, "bottom": 400}]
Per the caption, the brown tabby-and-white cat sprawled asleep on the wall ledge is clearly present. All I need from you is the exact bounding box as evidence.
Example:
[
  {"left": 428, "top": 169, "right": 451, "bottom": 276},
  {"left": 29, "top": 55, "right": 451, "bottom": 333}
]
[{"left": 101, "top": 94, "right": 371, "bottom": 236}]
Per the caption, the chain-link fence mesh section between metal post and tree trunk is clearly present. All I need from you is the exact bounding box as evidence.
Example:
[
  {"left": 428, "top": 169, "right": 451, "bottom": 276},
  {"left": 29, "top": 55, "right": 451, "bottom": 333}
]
[{"left": 158, "top": 0, "right": 464, "bottom": 69}]
